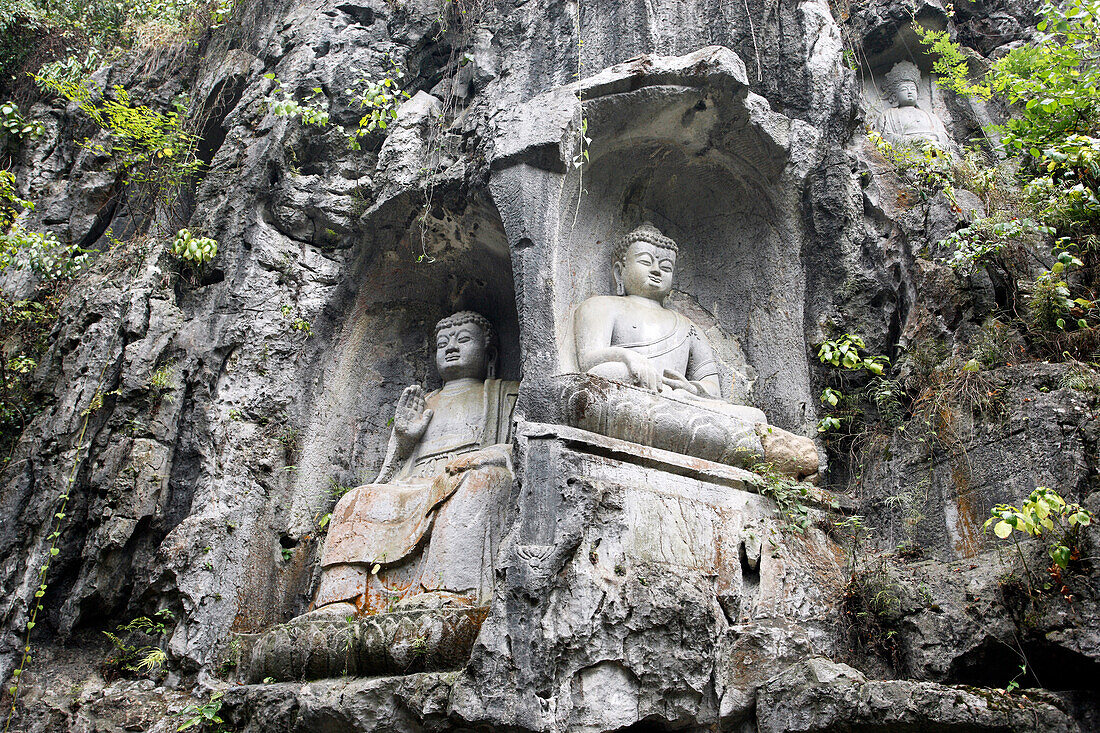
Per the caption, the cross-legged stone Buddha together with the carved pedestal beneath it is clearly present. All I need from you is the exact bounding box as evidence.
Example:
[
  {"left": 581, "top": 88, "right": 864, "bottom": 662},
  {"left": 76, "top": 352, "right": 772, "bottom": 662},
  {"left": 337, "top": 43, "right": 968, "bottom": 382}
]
[{"left": 563, "top": 223, "right": 818, "bottom": 480}]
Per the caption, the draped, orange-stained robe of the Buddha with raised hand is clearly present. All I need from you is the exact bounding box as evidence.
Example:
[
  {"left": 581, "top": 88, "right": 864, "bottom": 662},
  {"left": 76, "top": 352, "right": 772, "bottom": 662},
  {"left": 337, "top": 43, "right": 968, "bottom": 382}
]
[{"left": 315, "top": 380, "right": 518, "bottom": 612}]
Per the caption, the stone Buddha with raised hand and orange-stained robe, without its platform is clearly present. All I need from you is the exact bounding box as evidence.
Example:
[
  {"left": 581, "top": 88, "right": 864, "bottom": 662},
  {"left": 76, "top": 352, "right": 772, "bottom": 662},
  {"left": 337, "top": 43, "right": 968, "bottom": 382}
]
[{"left": 311, "top": 310, "right": 519, "bottom": 616}]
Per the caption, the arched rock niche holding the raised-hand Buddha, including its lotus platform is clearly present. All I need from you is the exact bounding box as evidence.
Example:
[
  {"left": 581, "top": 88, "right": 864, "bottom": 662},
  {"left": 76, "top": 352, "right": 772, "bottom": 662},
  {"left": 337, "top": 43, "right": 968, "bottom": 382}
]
[{"left": 237, "top": 192, "right": 520, "bottom": 682}]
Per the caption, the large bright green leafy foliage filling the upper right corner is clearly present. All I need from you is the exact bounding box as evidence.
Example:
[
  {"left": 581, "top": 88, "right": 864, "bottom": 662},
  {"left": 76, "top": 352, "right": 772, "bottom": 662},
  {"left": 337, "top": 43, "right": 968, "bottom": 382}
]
[{"left": 922, "top": 0, "right": 1100, "bottom": 359}]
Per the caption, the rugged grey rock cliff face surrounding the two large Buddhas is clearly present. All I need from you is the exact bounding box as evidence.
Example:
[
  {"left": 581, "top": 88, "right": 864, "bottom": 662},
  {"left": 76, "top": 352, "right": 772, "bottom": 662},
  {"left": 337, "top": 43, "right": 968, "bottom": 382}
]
[{"left": 0, "top": 0, "right": 1100, "bottom": 732}]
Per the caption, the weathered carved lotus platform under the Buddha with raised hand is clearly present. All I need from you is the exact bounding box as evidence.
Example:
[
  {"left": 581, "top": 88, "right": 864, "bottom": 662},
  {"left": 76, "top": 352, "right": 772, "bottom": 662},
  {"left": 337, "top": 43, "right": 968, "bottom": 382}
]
[{"left": 238, "top": 606, "right": 488, "bottom": 683}]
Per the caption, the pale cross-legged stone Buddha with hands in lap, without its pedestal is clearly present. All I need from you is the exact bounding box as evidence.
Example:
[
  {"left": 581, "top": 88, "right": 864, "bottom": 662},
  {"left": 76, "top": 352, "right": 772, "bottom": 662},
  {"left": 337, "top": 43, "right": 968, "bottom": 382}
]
[{"left": 573, "top": 222, "right": 818, "bottom": 480}]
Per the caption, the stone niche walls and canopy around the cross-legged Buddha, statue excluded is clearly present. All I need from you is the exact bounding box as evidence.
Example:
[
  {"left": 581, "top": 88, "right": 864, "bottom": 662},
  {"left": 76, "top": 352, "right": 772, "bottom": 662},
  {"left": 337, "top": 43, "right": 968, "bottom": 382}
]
[{"left": 491, "top": 46, "right": 823, "bottom": 458}]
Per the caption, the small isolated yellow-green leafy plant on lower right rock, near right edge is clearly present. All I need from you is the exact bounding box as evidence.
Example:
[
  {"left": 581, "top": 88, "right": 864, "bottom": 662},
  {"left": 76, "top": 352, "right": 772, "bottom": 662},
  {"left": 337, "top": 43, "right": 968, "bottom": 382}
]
[{"left": 982, "top": 486, "right": 1092, "bottom": 575}]
